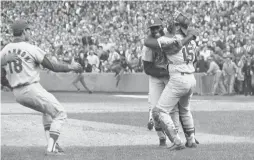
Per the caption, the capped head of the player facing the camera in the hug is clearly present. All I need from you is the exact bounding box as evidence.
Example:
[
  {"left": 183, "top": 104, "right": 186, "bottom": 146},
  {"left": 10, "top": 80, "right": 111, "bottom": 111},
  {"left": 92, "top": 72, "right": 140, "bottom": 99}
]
[{"left": 148, "top": 18, "right": 164, "bottom": 38}]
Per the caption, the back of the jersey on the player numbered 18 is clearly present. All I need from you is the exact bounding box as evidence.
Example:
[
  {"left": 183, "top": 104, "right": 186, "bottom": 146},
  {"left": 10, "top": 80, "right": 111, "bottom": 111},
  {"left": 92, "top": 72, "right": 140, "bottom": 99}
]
[{"left": 1, "top": 42, "right": 45, "bottom": 87}]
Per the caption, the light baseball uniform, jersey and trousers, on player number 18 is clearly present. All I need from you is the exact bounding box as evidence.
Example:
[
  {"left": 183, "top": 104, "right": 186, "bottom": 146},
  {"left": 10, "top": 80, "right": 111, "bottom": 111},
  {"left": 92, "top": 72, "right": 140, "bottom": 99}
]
[{"left": 1, "top": 42, "right": 67, "bottom": 141}]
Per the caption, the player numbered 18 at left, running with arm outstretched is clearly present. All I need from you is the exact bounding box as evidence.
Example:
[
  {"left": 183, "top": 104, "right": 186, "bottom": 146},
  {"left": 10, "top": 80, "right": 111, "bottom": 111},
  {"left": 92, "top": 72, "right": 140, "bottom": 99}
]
[{"left": 1, "top": 20, "right": 82, "bottom": 155}]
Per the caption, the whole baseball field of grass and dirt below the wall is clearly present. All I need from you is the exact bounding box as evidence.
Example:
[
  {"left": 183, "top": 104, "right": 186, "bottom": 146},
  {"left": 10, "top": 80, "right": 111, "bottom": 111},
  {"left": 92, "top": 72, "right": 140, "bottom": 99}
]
[{"left": 1, "top": 92, "right": 254, "bottom": 160}]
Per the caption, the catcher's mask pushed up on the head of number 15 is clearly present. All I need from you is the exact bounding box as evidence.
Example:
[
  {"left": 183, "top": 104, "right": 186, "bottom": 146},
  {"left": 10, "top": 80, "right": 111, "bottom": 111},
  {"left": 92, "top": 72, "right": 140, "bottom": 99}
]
[{"left": 173, "top": 10, "right": 191, "bottom": 35}]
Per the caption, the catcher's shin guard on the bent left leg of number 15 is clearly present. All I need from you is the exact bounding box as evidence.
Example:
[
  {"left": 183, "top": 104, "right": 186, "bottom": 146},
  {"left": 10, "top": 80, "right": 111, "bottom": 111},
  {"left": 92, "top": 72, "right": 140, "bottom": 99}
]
[{"left": 153, "top": 107, "right": 182, "bottom": 144}]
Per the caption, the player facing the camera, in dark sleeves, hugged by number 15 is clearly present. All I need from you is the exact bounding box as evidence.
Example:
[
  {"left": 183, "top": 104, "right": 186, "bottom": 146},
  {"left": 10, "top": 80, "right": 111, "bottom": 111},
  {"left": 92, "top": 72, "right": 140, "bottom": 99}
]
[{"left": 142, "top": 18, "right": 179, "bottom": 146}]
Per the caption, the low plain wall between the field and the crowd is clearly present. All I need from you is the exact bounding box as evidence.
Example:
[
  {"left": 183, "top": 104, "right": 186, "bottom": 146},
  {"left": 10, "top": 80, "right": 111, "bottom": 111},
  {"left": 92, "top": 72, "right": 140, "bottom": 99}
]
[{"left": 40, "top": 71, "right": 213, "bottom": 95}]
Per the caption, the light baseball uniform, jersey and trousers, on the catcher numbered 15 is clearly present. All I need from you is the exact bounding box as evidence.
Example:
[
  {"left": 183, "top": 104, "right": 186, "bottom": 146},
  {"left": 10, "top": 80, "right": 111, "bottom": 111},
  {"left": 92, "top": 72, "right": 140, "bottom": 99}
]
[{"left": 156, "top": 35, "right": 196, "bottom": 134}]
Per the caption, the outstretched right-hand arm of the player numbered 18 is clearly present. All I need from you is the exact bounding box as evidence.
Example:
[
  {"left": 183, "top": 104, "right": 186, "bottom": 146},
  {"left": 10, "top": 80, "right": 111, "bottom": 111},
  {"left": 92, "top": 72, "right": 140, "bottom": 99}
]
[{"left": 41, "top": 55, "right": 82, "bottom": 72}]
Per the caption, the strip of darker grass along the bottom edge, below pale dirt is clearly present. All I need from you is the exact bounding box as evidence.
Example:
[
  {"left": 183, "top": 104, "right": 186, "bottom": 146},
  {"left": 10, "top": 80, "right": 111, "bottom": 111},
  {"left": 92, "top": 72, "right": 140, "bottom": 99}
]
[{"left": 1, "top": 143, "right": 254, "bottom": 160}]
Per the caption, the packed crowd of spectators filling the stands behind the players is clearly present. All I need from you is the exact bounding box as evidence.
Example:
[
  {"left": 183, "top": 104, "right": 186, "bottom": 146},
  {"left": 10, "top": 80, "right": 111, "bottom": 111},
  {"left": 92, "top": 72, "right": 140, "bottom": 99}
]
[{"left": 1, "top": 0, "right": 254, "bottom": 94}]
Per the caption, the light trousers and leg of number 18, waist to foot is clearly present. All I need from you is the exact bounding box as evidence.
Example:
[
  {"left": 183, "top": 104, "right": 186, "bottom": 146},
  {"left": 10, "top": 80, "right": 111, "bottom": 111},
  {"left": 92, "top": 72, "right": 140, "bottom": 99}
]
[{"left": 13, "top": 83, "right": 67, "bottom": 154}]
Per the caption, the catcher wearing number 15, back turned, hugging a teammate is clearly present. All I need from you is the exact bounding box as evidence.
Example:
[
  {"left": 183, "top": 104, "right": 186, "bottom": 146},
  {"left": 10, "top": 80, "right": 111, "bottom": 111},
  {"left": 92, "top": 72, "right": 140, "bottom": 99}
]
[{"left": 145, "top": 11, "right": 198, "bottom": 150}]
